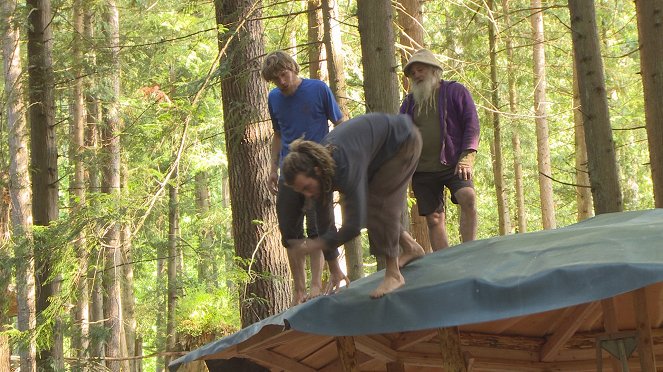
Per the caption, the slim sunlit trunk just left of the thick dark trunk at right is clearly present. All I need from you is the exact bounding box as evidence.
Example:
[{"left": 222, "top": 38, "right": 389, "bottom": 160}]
[{"left": 573, "top": 64, "right": 594, "bottom": 222}]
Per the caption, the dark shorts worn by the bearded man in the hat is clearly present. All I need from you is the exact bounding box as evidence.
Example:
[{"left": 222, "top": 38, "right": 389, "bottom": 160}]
[{"left": 412, "top": 168, "right": 474, "bottom": 216}]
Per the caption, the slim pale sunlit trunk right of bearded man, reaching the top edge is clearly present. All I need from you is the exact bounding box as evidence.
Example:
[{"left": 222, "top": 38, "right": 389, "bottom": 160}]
[{"left": 530, "top": 0, "right": 557, "bottom": 230}]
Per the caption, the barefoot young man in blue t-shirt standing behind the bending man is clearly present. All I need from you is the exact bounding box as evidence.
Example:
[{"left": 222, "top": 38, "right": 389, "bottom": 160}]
[{"left": 261, "top": 50, "right": 343, "bottom": 305}]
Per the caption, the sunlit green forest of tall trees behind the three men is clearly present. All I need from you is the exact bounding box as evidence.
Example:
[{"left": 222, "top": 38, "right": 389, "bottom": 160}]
[{"left": 0, "top": 0, "right": 663, "bottom": 372}]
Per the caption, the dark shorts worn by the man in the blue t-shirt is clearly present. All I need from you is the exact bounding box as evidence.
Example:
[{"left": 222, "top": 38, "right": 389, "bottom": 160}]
[{"left": 276, "top": 179, "right": 338, "bottom": 260}]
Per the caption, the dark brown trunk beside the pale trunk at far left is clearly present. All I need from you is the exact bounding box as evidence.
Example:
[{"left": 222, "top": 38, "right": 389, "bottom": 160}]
[{"left": 27, "top": 0, "right": 64, "bottom": 371}]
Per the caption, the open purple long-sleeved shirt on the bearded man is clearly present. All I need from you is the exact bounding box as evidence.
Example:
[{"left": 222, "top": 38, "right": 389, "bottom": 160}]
[{"left": 400, "top": 80, "right": 479, "bottom": 166}]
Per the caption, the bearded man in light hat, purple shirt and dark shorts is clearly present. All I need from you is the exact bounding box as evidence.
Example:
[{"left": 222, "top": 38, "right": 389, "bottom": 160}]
[{"left": 400, "top": 49, "right": 479, "bottom": 250}]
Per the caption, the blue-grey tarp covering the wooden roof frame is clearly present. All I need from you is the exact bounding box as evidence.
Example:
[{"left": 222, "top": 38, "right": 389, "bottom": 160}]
[{"left": 170, "top": 209, "right": 663, "bottom": 371}]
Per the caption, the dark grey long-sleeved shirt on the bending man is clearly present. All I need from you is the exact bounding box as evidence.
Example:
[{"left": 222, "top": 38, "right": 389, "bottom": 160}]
[{"left": 321, "top": 113, "right": 415, "bottom": 249}]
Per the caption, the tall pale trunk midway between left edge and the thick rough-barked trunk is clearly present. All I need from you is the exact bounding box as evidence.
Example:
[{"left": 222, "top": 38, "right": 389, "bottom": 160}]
[{"left": 101, "top": 0, "right": 128, "bottom": 372}]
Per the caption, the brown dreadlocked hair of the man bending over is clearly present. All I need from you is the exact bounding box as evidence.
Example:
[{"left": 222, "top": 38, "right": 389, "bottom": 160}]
[{"left": 281, "top": 139, "right": 336, "bottom": 201}]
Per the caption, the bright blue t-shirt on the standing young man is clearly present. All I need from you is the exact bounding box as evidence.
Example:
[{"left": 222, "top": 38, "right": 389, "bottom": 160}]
[{"left": 267, "top": 78, "right": 343, "bottom": 164}]
